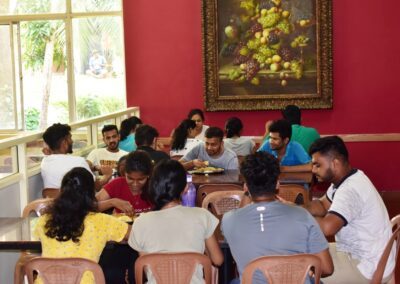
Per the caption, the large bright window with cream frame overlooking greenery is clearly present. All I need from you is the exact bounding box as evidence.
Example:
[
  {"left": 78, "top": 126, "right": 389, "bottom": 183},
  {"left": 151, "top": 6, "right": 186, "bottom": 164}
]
[{"left": 0, "top": 0, "right": 126, "bottom": 130}]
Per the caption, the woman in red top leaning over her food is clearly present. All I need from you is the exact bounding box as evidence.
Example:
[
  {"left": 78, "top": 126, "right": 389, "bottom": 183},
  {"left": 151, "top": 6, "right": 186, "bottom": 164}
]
[{"left": 96, "top": 151, "right": 153, "bottom": 215}]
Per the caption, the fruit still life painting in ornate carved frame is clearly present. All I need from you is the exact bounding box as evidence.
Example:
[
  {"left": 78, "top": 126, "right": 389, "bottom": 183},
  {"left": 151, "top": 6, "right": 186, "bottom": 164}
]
[{"left": 202, "top": 0, "right": 332, "bottom": 111}]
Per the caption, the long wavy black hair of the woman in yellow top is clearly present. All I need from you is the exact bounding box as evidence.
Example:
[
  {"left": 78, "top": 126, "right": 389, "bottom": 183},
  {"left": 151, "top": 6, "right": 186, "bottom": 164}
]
[{"left": 45, "top": 167, "right": 97, "bottom": 243}]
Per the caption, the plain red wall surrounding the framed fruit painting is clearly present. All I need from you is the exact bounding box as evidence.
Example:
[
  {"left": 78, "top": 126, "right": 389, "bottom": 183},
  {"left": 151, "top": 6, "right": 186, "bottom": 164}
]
[{"left": 124, "top": 0, "right": 400, "bottom": 190}]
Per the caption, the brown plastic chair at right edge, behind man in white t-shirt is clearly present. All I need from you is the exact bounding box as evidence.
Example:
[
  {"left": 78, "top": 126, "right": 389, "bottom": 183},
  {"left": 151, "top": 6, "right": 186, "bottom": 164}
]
[{"left": 371, "top": 215, "right": 400, "bottom": 284}]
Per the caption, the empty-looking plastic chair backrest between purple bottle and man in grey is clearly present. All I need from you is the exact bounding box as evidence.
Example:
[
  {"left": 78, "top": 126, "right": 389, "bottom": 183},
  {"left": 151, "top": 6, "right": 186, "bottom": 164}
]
[{"left": 201, "top": 190, "right": 244, "bottom": 217}]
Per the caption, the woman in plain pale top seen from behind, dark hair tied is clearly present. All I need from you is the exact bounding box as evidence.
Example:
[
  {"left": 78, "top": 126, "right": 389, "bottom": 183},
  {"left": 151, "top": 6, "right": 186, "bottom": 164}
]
[{"left": 128, "top": 160, "right": 223, "bottom": 283}]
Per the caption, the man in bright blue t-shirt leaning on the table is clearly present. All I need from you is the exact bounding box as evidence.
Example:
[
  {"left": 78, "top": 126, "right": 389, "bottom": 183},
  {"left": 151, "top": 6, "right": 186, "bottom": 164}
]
[{"left": 258, "top": 119, "right": 311, "bottom": 171}]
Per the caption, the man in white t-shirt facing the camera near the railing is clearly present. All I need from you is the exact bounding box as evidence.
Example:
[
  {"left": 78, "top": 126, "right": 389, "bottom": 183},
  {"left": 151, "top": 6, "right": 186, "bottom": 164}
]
[{"left": 87, "top": 124, "right": 128, "bottom": 172}]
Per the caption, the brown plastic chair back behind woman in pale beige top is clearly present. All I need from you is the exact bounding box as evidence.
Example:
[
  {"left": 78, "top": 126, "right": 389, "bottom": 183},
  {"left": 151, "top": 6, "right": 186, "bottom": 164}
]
[{"left": 135, "top": 252, "right": 211, "bottom": 284}]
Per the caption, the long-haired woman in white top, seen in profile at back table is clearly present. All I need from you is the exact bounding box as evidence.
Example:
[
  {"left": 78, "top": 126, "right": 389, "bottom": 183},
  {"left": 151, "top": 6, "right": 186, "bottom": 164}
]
[{"left": 169, "top": 119, "right": 202, "bottom": 157}]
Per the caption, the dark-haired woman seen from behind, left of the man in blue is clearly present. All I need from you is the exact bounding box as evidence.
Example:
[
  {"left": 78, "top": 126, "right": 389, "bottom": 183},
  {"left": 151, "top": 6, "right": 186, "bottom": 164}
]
[{"left": 224, "top": 117, "right": 255, "bottom": 156}]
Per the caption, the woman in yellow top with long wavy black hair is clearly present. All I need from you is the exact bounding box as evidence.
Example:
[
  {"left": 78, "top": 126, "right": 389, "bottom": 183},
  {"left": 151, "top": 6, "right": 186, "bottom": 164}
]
[{"left": 35, "top": 167, "right": 131, "bottom": 283}]
